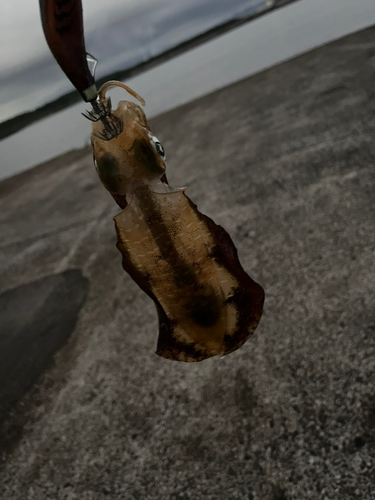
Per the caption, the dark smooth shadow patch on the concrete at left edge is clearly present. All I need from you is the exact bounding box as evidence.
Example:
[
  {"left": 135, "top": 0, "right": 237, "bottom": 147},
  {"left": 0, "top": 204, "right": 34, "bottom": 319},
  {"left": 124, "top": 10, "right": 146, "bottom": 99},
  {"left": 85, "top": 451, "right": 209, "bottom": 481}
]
[{"left": 0, "top": 269, "right": 88, "bottom": 421}]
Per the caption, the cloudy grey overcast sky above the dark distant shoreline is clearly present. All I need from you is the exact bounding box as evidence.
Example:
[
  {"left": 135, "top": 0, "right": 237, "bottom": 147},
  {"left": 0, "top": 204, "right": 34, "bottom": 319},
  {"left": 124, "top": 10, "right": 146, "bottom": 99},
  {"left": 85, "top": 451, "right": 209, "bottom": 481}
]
[{"left": 0, "top": 0, "right": 266, "bottom": 121}]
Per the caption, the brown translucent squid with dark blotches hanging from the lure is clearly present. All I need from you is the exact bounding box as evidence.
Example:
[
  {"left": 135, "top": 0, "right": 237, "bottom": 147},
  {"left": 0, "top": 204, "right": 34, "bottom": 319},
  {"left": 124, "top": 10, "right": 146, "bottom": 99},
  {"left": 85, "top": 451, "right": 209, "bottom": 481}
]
[{"left": 87, "top": 81, "right": 264, "bottom": 362}]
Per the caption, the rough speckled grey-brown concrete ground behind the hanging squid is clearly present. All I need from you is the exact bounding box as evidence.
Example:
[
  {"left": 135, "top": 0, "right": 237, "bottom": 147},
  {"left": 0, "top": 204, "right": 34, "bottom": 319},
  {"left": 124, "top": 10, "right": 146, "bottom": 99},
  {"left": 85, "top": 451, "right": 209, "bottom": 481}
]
[{"left": 0, "top": 28, "right": 375, "bottom": 500}]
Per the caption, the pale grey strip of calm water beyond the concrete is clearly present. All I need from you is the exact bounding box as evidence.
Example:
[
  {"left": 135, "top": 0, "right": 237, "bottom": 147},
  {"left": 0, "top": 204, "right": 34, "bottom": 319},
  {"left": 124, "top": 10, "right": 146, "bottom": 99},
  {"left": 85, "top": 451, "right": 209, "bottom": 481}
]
[{"left": 0, "top": 0, "right": 375, "bottom": 182}]
